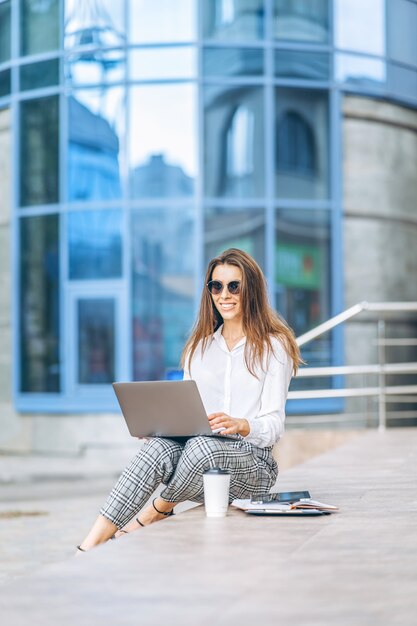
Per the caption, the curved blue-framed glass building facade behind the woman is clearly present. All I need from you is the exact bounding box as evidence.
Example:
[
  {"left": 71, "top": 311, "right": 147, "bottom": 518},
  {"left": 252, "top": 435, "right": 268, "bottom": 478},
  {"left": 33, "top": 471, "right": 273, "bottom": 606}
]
[{"left": 0, "top": 0, "right": 417, "bottom": 412}]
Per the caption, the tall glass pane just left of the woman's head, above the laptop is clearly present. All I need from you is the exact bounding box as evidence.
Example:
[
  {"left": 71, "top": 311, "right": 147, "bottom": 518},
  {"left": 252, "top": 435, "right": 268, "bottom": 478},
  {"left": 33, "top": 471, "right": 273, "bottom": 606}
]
[{"left": 132, "top": 208, "right": 196, "bottom": 380}]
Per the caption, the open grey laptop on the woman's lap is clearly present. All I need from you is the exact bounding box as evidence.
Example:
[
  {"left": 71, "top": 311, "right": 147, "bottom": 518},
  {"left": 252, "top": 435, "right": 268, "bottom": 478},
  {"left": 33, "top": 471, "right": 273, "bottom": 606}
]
[{"left": 113, "top": 380, "right": 240, "bottom": 439}]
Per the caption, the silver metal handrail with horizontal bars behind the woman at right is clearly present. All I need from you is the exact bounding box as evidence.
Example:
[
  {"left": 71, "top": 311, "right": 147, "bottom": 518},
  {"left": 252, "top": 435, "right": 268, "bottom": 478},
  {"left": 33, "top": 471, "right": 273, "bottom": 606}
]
[{"left": 288, "top": 300, "right": 417, "bottom": 430}]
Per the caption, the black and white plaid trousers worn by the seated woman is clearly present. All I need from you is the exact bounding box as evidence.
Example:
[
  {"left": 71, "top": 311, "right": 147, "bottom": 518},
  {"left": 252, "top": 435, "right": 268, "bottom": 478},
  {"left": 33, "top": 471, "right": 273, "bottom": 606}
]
[{"left": 100, "top": 436, "right": 278, "bottom": 528}]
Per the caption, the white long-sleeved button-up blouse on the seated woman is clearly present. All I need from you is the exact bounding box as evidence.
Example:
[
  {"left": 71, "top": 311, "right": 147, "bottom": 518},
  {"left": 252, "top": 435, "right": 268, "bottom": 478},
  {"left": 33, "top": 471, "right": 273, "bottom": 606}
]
[{"left": 184, "top": 325, "right": 293, "bottom": 448}]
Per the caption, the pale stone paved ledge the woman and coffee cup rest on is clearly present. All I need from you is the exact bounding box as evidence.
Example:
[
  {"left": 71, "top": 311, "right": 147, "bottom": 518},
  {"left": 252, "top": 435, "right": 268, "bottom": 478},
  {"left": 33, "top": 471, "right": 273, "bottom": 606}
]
[{"left": 0, "top": 429, "right": 417, "bottom": 626}]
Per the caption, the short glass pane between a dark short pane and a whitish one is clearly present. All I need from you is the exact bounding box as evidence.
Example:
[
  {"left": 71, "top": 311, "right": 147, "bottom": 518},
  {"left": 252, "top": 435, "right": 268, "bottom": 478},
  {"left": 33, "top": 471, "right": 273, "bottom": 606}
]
[{"left": 64, "top": 48, "right": 126, "bottom": 85}]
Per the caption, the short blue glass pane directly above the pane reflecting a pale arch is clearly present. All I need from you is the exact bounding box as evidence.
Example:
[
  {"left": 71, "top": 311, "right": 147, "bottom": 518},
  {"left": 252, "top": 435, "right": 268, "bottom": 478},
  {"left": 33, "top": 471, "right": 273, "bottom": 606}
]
[{"left": 203, "top": 48, "right": 264, "bottom": 76}]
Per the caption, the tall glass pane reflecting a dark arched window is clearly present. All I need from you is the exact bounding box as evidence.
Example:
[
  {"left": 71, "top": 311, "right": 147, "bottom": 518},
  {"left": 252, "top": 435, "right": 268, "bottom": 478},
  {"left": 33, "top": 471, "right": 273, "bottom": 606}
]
[{"left": 275, "top": 89, "right": 329, "bottom": 200}]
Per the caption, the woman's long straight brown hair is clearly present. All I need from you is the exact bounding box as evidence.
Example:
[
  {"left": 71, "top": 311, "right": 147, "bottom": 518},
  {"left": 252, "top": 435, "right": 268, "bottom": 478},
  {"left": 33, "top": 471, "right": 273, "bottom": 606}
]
[{"left": 181, "top": 248, "right": 303, "bottom": 376}]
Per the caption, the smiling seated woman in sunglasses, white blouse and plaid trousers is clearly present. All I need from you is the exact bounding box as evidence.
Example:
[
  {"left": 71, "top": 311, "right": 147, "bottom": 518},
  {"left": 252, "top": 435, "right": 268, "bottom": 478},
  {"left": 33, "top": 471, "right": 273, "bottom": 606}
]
[{"left": 78, "top": 248, "right": 301, "bottom": 551}]
